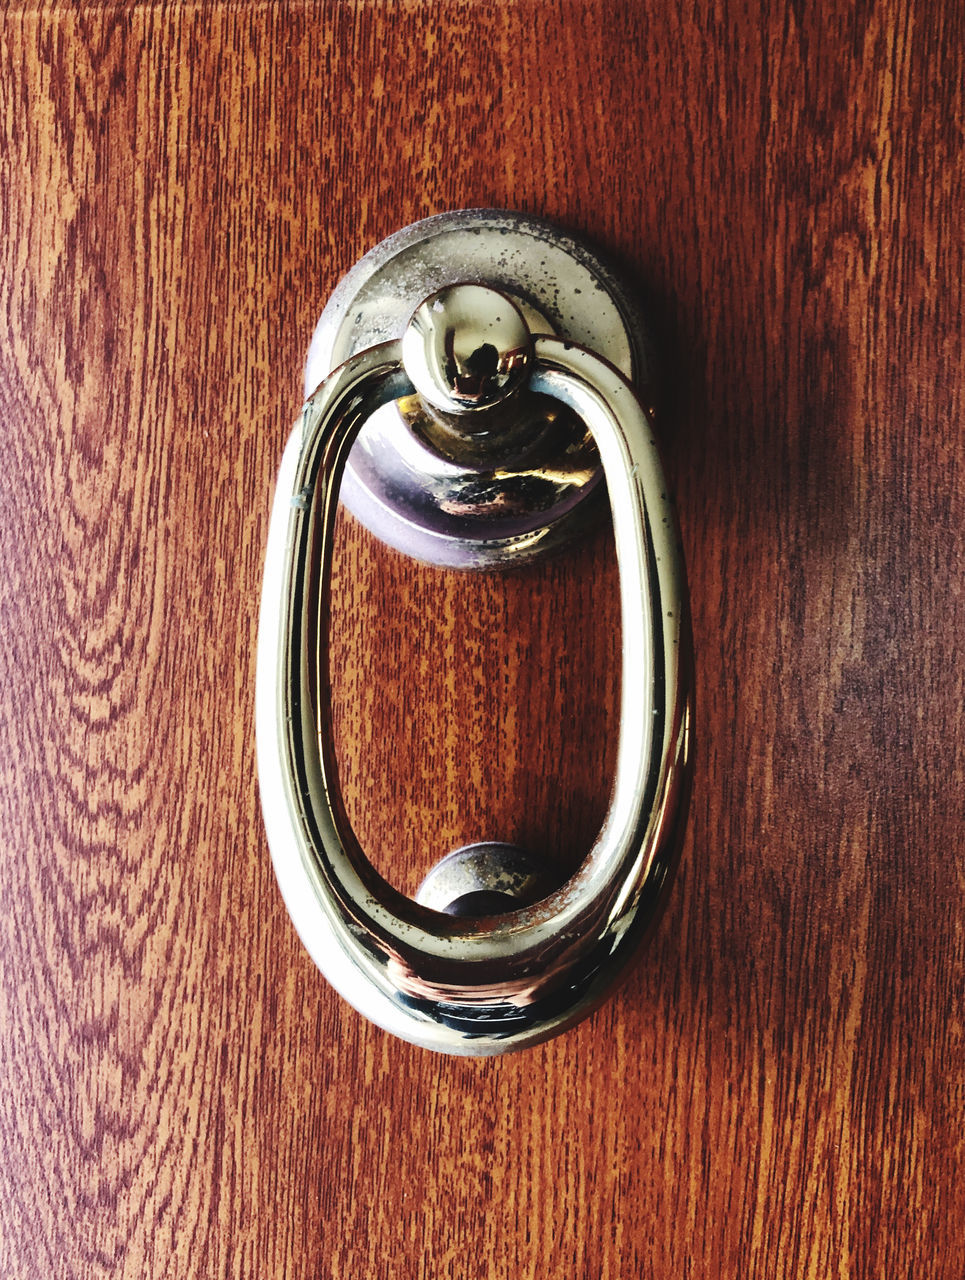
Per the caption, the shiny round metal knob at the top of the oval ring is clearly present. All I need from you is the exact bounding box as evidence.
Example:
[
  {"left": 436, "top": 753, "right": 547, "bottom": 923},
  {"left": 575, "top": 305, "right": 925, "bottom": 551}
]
[{"left": 402, "top": 284, "right": 532, "bottom": 413}]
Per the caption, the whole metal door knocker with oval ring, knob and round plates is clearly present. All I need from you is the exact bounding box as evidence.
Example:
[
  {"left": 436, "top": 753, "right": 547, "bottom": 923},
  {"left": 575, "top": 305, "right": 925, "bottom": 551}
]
[{"left": 256, "top": 210, "right": 692, "bottom": 1056}]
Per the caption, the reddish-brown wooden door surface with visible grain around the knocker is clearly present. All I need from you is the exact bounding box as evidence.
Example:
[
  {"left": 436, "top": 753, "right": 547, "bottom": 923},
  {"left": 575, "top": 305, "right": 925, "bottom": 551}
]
[{"left": 0, "top": 0, "right": 965, "bottom": 1280}]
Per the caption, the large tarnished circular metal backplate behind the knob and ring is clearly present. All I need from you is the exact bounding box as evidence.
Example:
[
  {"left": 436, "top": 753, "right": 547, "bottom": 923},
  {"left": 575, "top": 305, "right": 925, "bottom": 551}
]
[{"left": 305, "top": 209, "right": 651, "bottom": 568}]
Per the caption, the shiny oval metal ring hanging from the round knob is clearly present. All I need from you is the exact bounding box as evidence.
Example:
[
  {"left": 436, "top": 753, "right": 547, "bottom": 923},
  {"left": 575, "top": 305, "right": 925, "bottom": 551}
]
[{"left": 256, "top": 338, "right": 692, "bottom": 1056}]
